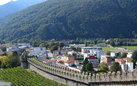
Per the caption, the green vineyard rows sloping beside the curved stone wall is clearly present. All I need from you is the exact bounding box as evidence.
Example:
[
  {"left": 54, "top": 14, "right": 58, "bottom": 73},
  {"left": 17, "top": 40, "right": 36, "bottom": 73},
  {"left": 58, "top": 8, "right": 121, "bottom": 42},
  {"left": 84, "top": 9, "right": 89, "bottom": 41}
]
[{"left": 0, "top": 67, "right": 66, "bottom": 86}]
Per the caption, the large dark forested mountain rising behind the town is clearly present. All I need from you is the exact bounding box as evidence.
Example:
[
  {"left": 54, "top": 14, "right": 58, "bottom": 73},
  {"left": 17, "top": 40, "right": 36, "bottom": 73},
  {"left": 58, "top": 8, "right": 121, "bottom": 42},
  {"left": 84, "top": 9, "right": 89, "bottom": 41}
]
[{"left": 0, "top": 0, "right": 137, "bottom": 40}]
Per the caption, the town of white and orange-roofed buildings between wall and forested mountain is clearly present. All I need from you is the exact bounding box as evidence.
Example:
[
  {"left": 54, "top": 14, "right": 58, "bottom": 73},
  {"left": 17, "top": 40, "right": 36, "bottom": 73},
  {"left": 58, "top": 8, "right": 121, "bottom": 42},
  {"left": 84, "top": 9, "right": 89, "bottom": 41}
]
[{"left": 1, "top": 41, "right": 136, "bottom": 72}]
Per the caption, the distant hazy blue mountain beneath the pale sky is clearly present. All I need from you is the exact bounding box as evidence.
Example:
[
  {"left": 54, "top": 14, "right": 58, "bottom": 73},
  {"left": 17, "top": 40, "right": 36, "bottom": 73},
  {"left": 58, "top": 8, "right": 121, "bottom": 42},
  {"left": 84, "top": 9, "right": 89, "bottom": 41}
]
[{"left": 0, "top": 0, "right": 46, "bottom": 18}]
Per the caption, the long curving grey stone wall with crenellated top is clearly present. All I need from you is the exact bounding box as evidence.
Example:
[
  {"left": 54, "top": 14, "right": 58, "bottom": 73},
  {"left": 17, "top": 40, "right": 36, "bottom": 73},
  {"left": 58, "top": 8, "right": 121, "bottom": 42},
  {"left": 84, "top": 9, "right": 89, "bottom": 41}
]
[{"left": 28, "top": 59, "right": 137, "bottom": 86}]
